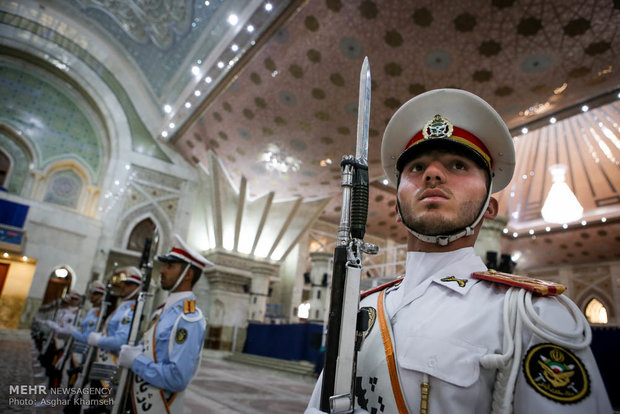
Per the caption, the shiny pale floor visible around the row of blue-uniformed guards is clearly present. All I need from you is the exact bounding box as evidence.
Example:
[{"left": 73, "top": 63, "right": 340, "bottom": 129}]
[{"left": 0, "top": 330, "right": 315, "bottom": 414}]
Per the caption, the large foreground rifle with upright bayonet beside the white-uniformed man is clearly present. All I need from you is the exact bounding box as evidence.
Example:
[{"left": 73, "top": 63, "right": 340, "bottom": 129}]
[{"left": 320, "top": 57, "right": 378, "bottom": 413}]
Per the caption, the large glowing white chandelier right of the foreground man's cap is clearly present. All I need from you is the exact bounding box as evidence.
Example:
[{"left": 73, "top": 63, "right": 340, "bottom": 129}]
[{"left": 540, "top": 164, "right": 583, "bottom": 224}]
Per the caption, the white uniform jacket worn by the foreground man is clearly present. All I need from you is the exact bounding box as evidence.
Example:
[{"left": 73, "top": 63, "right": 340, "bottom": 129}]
[{"left": 307, "top": 248, "right": 612, "bottom": 414}]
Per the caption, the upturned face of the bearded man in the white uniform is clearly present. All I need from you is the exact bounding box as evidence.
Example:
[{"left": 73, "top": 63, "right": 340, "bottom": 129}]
[{"left": 397, "top": 149, "right": 487, "bottom": 236}]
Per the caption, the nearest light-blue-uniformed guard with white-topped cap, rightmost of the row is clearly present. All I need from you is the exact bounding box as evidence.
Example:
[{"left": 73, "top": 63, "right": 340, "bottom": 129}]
[{"left": 119, "top": 236, "right": 212, "bottom": 413}]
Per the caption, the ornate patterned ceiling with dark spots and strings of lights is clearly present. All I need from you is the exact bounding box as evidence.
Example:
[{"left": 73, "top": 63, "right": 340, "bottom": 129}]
[{"left": 0, "top": 0, "right": 620, "bottom": 267}]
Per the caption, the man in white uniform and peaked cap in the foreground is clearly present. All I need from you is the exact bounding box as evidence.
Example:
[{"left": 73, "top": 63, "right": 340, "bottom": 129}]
[{"left": 306, "top": 89, "right": 612, "bottom": 414}]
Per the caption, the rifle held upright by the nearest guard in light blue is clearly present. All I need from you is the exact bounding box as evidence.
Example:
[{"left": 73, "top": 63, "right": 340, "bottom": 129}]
[{"left": 112, "top": 228, "right": 159, "bottom": 414}]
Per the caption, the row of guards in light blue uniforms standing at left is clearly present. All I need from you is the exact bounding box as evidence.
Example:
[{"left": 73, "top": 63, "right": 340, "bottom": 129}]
[{"left": 33, "top": 235, "right": 212, "bottom": 413}]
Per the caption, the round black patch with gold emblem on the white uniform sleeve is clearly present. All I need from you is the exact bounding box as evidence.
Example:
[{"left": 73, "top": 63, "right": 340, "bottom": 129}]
[{"left": 523, "top": 343, "right": 590, "bottom": 404}]
